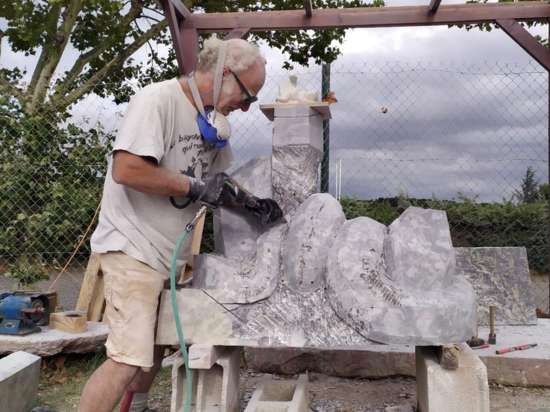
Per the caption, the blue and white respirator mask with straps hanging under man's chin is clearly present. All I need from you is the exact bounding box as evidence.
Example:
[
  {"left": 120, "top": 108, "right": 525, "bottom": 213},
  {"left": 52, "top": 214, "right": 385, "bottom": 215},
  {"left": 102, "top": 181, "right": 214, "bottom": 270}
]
[{"left": 187, "top": 41, "right": 231, "bottom": 149}]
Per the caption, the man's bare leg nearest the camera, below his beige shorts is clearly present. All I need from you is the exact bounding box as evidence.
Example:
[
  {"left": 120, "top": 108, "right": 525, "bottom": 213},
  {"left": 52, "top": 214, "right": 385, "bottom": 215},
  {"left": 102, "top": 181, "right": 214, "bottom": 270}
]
[{"left": 78, "top": 359, "right": 139, "bottom": 412}]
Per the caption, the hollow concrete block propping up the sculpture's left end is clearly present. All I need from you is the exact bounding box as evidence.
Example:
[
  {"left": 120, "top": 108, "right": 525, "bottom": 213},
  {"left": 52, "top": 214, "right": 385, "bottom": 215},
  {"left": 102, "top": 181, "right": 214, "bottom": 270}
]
[{"left": 170, "top": 347, "right": 241, "bottom": 412}]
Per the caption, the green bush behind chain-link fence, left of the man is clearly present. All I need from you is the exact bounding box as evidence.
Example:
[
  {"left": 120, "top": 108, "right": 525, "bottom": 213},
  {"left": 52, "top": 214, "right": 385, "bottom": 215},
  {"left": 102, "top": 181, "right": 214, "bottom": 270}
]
[{"left": 0, "top": 100, "right": 112, "bottom": 283}]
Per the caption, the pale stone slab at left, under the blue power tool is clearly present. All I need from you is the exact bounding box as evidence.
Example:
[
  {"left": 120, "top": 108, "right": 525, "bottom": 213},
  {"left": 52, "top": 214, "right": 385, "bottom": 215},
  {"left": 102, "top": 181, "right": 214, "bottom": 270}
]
[{"left": 0, "top": 322, "right": 109, "bottom": 356}]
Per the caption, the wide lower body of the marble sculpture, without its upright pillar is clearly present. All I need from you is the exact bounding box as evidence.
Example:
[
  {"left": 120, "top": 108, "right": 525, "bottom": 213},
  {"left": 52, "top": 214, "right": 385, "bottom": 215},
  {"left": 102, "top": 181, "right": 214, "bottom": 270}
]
[{"left": 157, "top": 200, "right": 476, "bottom": 349}]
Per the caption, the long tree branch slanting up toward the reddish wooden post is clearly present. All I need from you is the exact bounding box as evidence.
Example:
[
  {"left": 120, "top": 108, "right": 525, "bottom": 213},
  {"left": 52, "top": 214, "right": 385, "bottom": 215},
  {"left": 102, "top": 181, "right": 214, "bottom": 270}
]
[{"left": 52, "top": 20, "right": 168, "bottom": 111}]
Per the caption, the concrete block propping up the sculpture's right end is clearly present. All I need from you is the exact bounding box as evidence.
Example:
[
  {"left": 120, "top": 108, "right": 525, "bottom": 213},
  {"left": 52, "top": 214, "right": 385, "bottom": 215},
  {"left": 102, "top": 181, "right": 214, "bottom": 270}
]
[{"left": 416, "top": 344, "right": 489, "bottom": 412}]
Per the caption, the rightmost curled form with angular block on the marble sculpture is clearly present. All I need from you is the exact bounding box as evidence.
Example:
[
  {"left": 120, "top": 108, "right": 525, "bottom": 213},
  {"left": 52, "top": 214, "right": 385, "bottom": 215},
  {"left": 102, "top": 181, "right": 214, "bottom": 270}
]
[{"left": 327, "top": 208, "right": 476, "bottom": 345}]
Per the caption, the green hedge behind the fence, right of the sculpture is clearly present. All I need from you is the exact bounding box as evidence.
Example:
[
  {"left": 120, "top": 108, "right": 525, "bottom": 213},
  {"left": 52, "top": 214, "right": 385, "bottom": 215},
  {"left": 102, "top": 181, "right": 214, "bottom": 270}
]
[{"left": 341, "top": 198, "right": 549, "bottom": 273}]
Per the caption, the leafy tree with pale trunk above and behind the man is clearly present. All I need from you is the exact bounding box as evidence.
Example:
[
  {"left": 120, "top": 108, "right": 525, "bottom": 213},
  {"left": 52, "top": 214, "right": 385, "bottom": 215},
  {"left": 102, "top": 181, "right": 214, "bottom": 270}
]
[{"left": 0, "top": 0, "right": 384, "bottom": 115}]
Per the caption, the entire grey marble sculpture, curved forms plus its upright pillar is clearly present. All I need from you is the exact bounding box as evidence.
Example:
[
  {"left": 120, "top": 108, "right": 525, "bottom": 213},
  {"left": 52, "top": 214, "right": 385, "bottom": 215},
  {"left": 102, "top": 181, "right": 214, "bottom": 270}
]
[{"left": 157, "top": 106, "right": 476, "bottom": 349}]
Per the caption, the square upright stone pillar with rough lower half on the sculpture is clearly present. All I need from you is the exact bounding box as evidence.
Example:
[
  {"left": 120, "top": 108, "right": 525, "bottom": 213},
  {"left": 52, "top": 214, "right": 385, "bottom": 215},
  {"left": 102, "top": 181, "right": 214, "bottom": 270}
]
[{"left": 268, "top": 104, "right": 330, "bottom": 214}]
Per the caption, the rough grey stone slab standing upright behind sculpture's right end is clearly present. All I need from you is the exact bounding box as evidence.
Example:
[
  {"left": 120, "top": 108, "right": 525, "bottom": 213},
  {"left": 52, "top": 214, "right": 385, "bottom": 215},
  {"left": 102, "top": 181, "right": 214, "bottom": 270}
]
[{"left": 455, "top": 247, "right": 548, "bottom": 325}]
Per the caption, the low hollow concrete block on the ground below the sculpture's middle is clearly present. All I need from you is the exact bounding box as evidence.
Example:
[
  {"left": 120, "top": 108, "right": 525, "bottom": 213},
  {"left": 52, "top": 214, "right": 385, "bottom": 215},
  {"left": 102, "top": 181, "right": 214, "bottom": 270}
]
[{"left": 244, "top": 375, "right": 309, "bottom": 412}]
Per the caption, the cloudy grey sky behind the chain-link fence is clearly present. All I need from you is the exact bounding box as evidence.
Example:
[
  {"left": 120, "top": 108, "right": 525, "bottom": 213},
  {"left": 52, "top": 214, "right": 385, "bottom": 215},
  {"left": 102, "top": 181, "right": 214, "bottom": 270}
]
[{"left": 0, "top": 0, "right": 548, "bottom": 201}]
